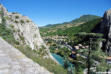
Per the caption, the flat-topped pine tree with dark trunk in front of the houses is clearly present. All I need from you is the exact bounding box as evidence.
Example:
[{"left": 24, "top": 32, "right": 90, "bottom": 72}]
[{"left": 73, "top": 32, "right": 107, "bottom": 74}]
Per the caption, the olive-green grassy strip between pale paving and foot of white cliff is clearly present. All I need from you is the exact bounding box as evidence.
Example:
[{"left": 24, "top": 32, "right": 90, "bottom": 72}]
[{"left": 16, "top": 46, "right": 67, "bottom": 74}]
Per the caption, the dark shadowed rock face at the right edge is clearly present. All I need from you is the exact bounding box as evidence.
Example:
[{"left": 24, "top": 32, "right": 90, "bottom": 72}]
[{"left": 101, "top": 9, "right": 111, "bottom": 56}]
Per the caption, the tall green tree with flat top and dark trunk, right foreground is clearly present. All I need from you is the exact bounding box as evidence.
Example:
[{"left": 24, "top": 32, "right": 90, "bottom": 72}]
[{"left": 74, "top": 32, "right": 107, "bottom": 74}]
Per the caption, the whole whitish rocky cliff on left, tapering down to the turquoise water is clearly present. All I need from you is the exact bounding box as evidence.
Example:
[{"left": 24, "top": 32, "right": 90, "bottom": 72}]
[{"left": 0, "top": 4, "right": 58, "bottom": 63}]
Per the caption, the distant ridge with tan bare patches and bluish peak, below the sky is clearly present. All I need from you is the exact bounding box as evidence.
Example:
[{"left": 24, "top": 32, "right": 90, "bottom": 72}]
[{"left": 40, "top": 15, "right": 100, "bottom": 36}]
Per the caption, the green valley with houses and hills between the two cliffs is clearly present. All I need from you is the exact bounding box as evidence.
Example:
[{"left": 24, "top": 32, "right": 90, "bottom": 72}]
[{"left": 40, "top": 10, "right": 110, "bottom": 74}]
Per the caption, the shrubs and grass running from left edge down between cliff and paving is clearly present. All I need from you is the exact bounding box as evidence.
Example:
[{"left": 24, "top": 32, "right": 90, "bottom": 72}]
[{"left": 0, "top": 6, "right": 67, "bottom": 74}]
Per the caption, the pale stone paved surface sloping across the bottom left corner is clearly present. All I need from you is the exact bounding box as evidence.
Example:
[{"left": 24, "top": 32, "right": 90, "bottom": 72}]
[{"left": 0, "top": 38, "right": 51, "bottom": 74}]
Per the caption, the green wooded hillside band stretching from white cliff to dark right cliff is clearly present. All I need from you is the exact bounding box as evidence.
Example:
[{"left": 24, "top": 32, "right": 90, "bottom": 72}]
[{"left": 40, "top": 18, "right": 102, "bottom": 37}]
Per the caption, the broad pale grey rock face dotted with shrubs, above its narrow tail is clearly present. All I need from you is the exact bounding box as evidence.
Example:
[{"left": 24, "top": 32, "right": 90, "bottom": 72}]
[{"left": 0, "top": 5, "right": 46, "bottom": 50}]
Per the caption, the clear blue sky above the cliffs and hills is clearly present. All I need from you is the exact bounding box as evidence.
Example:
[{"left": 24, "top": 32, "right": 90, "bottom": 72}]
[{"left": 0, "top": 0, "right": 111, "bottom": 26}]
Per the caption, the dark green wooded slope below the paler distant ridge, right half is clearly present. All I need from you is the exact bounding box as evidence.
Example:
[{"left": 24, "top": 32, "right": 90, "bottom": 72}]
[{"left": 56, "top": 18, "right": 101, "bottom": 36}]
